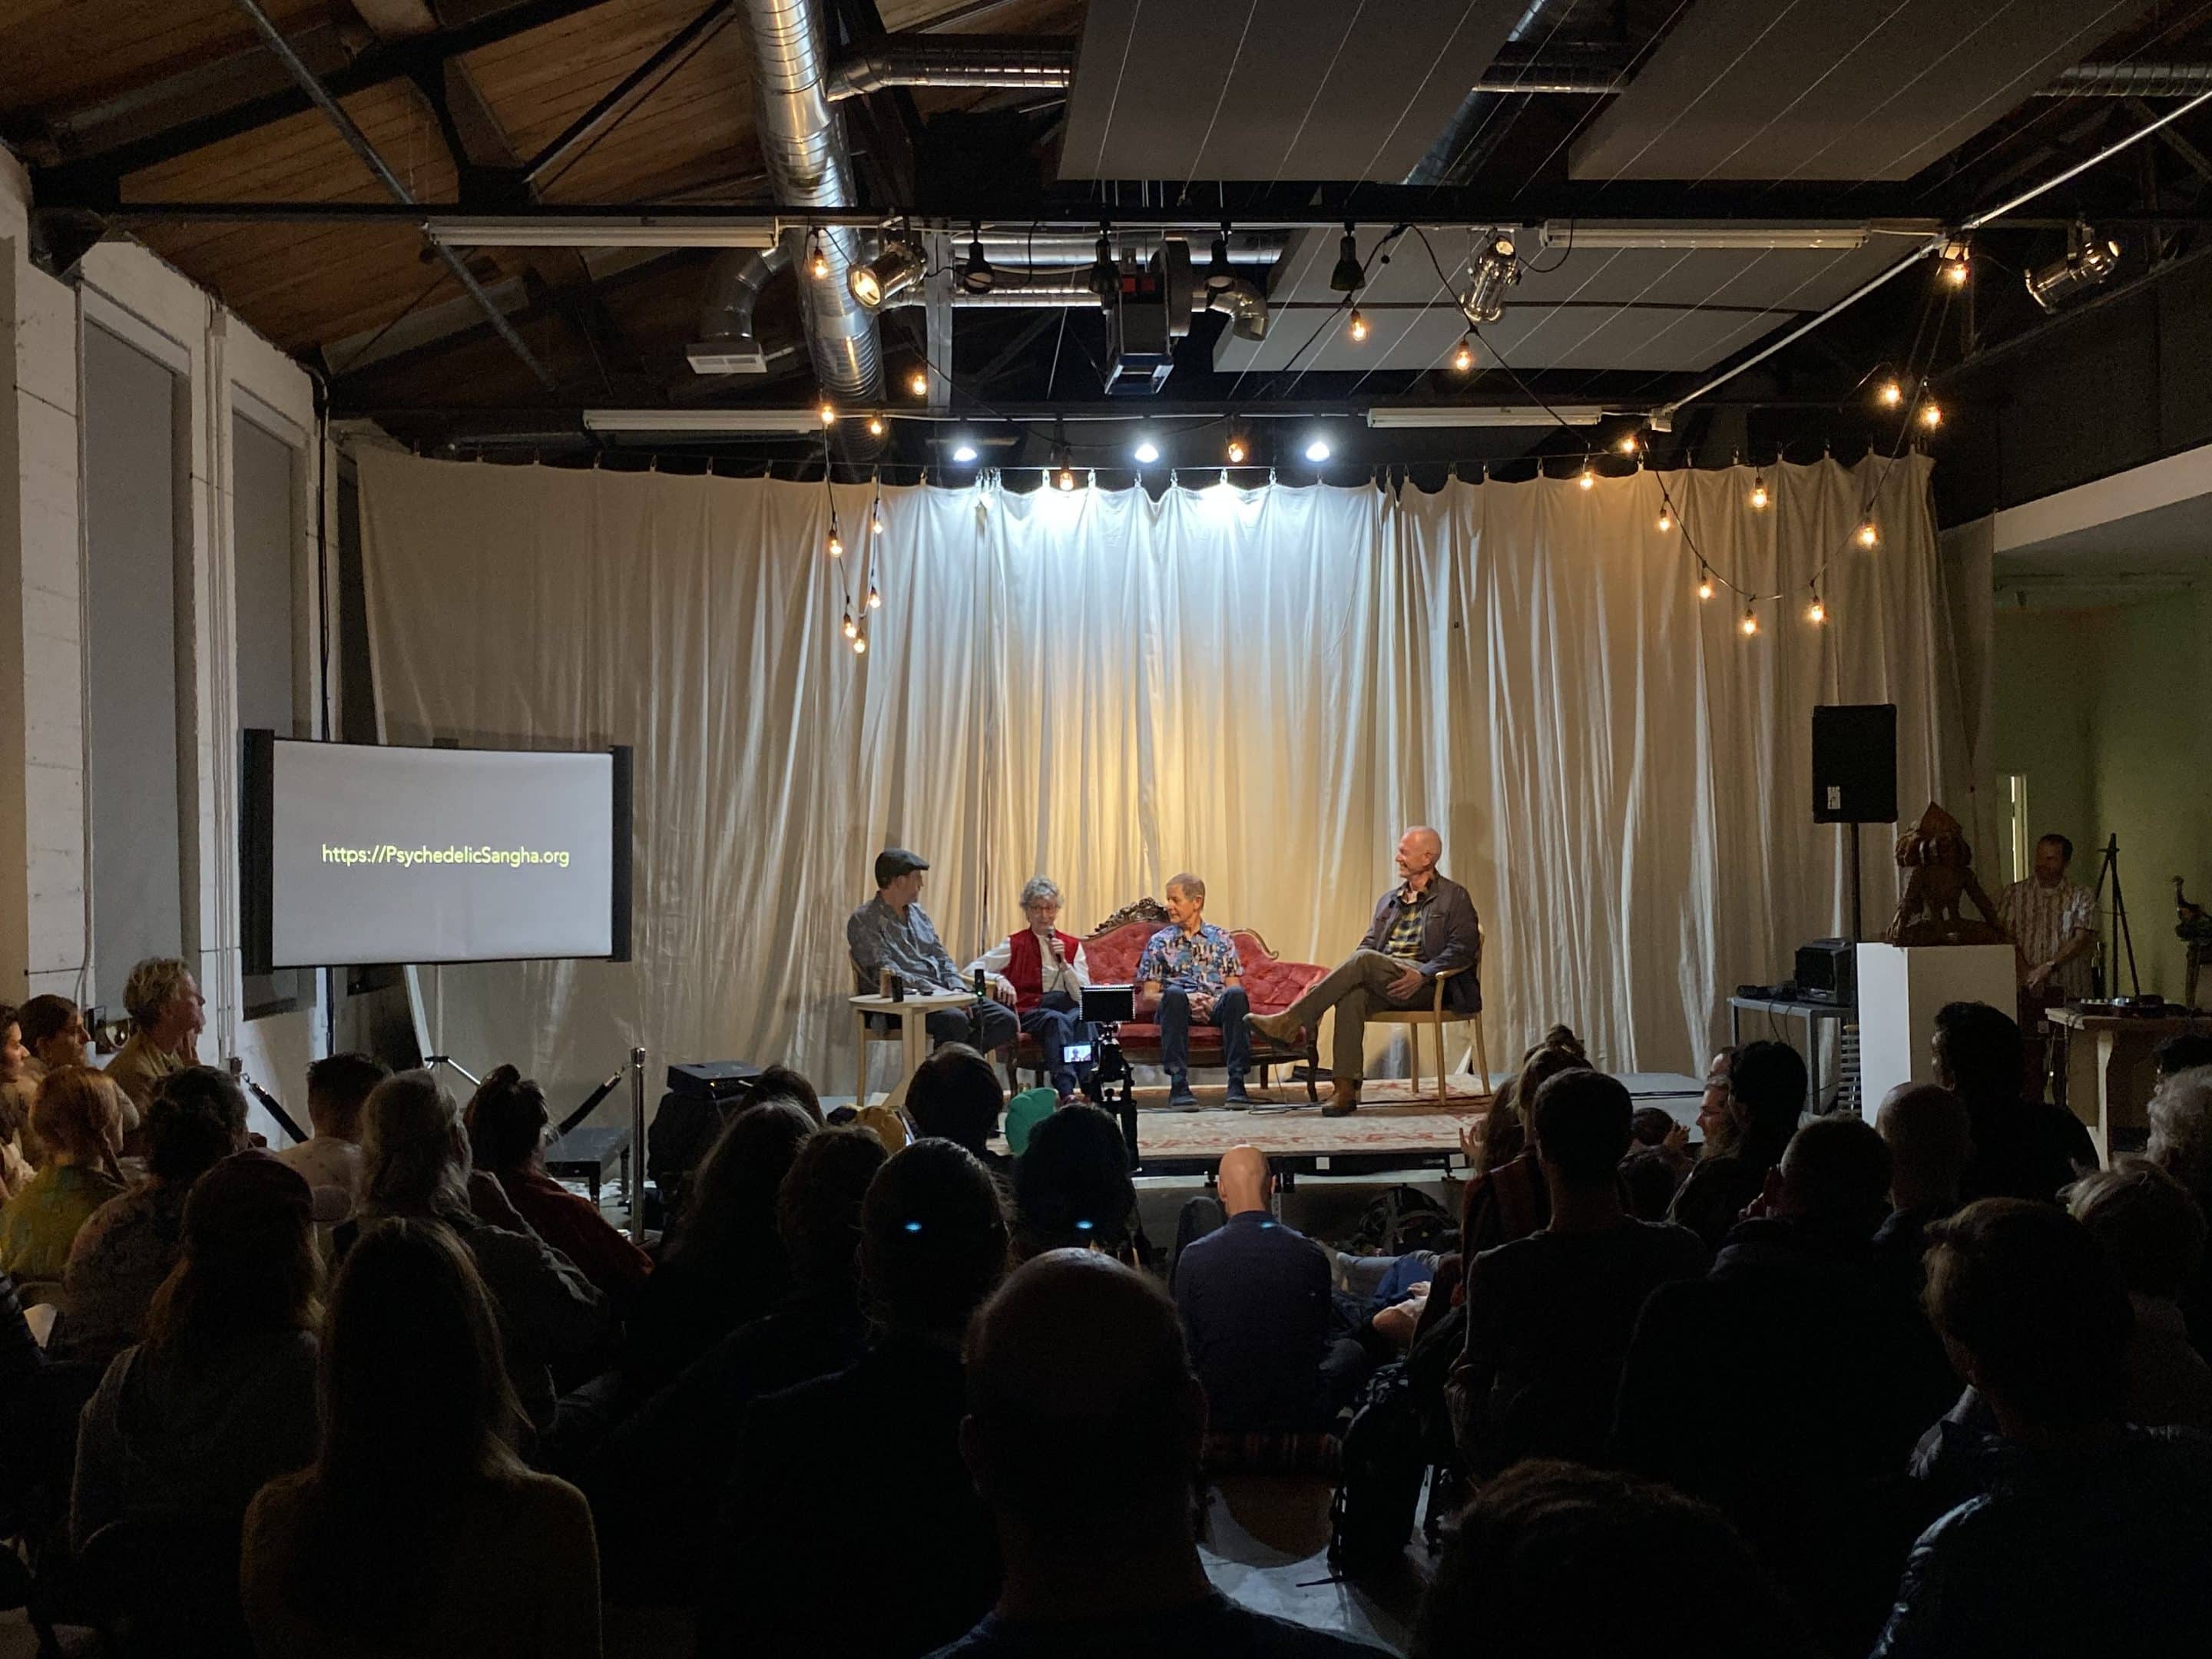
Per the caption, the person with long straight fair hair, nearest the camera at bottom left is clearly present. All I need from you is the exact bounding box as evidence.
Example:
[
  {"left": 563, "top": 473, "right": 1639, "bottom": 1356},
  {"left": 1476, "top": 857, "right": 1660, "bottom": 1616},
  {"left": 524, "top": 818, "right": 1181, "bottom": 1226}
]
[{"left": 241, "top": 1220, "right": 599, "bottom": 1659}]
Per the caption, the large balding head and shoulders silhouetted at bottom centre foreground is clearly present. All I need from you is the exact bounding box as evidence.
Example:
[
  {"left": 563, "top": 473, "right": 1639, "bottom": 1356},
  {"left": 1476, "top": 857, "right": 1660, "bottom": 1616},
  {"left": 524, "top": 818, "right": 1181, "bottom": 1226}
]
[{"left": 933, "top": 1250, "right": 1376, "bottom": 1659}]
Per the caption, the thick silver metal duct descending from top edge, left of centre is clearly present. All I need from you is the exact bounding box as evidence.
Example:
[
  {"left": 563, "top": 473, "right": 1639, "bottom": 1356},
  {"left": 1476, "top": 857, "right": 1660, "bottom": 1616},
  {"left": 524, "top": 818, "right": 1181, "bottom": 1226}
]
[{"left": 739, "top": 0, "right": 882, "bottom": 402}]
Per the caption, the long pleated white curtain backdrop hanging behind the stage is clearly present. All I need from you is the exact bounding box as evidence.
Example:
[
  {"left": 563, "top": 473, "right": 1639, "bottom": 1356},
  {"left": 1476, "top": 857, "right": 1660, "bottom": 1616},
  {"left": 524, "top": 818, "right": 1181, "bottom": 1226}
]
[{"left": 360, "top": 452, "right": 1966, "bottom": 1110}]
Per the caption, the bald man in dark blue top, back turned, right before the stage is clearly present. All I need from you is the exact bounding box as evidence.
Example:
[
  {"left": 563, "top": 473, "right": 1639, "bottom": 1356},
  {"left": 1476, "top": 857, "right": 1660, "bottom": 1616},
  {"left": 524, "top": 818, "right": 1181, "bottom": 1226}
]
[{"left": 1174, "top": 1146, "right": 1343, "bottom": 1433}]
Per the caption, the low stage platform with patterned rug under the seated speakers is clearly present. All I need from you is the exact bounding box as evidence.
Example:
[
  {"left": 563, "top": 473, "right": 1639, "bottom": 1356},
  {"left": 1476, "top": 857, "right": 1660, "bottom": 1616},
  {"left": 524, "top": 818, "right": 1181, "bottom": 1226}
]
[{"left": 998, "top": 1073, "right": 1704, "bottom": 1179}]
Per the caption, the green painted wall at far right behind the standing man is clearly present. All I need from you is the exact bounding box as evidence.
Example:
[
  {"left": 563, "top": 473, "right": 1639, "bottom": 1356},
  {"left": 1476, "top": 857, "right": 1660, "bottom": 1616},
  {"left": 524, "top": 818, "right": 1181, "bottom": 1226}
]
[{"left": 1975, "top": 588, "right": 2212, "bottom": 1000}]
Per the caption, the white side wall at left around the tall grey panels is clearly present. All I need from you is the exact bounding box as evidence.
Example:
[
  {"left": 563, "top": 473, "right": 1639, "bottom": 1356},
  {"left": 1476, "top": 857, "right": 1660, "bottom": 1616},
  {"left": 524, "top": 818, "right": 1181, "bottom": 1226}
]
[{"left": 0, "top": 151, "right": 334, "bottom": 1133}]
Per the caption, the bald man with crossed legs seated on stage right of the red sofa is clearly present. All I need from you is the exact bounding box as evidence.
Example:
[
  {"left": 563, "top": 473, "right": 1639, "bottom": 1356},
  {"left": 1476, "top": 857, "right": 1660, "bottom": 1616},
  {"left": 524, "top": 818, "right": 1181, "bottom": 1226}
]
[{"left": 1247, "top": 825, "right": 1482, "bottom": 1117}]
